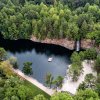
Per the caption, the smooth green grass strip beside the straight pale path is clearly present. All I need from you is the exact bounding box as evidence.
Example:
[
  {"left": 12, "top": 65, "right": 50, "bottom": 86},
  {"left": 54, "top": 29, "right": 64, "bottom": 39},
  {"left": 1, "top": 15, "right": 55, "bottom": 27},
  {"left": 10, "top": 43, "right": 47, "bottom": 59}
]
[{"left": 24, "top": 80, "right": 50, "bottom": 99}]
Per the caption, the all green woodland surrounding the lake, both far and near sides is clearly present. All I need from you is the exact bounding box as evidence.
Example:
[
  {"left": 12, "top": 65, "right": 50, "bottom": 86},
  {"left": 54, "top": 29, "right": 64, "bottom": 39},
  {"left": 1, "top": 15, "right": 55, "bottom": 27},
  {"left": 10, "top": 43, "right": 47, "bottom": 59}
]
[{"left": 0, "top": 0, "right": 100, "bottom": 100}]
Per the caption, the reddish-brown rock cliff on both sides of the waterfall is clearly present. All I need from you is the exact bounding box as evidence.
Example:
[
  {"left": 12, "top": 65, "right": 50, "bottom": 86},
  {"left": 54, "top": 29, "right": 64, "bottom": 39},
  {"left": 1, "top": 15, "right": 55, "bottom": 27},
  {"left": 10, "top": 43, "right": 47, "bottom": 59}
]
[{"left": 31, "top": 36, "right": 100, "bottom": 50}]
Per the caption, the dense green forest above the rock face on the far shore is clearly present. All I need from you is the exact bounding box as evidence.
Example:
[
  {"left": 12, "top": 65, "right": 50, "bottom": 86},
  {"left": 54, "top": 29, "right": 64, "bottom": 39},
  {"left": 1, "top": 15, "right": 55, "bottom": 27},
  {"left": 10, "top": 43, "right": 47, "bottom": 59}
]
[{"left": 0, "top": 0, "right": 100, "bottom": 45}]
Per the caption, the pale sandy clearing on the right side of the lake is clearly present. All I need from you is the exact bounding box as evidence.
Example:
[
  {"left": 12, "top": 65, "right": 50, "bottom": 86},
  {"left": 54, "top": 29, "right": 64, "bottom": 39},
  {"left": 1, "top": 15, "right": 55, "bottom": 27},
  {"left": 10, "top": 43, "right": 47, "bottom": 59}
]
[{"left": 61, "top": 61, "right": 97, "bottom": 94}]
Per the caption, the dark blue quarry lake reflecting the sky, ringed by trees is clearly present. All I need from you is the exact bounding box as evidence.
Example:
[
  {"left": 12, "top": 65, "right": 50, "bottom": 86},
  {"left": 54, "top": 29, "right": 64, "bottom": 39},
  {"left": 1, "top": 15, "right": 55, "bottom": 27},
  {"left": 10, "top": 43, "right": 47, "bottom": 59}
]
[{"left": 0, "top": 39, "right": 73, "bottom": 84}]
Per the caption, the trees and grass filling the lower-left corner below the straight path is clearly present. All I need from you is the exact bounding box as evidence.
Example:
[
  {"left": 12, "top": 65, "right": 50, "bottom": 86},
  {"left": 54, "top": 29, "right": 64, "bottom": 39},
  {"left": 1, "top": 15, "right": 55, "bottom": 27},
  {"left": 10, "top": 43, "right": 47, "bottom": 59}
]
[{"left": 0, "top": 60, "right": 50, "bottom": 100}]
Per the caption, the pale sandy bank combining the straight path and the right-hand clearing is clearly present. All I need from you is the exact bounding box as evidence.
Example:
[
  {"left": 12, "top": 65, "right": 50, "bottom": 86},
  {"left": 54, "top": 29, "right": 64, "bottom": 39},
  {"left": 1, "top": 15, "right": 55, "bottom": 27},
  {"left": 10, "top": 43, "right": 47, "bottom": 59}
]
[{"left": 13, "top": 60, "right": 97, "bottom": 96}]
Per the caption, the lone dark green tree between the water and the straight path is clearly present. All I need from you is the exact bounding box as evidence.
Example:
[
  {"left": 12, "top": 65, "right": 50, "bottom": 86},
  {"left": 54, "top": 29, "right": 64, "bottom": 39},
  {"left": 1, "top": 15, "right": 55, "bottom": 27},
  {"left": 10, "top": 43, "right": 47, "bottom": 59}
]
[{"left": 22, "top": 62, "right": 33, "bottom": 75}]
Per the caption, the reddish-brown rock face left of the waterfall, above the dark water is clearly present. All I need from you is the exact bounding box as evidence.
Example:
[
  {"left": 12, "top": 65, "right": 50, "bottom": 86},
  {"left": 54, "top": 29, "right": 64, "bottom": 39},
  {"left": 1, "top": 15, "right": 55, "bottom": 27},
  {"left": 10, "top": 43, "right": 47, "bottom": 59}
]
[{"left": 31, "top": 36, "right": 75, "bottom": 50}]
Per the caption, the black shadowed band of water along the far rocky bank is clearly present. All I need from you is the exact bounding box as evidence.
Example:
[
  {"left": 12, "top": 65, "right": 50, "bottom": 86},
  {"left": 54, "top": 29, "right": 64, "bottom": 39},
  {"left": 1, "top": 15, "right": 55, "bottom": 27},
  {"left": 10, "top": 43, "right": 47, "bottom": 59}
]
[{"left": 0, "top": 38, "right": 73, "bottom": 56}]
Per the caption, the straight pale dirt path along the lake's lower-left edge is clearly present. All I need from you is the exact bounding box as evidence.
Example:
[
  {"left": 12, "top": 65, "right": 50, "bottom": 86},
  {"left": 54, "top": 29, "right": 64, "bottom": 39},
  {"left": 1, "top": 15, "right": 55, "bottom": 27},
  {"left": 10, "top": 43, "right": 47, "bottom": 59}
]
[{"left": 13, "top": 69, "right": 54, "bottom": 96}]
